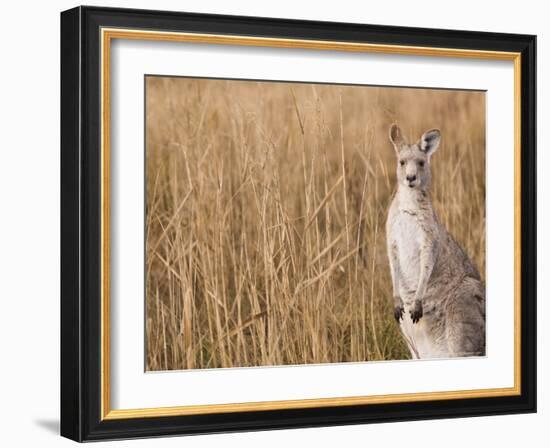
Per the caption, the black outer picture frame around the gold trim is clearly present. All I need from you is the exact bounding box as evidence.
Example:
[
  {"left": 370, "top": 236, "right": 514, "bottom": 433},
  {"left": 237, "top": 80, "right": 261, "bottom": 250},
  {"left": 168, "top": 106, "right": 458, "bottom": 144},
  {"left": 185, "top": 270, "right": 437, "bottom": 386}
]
[{"left": 61, "top": 7, "right": 537, "bottom": 441}]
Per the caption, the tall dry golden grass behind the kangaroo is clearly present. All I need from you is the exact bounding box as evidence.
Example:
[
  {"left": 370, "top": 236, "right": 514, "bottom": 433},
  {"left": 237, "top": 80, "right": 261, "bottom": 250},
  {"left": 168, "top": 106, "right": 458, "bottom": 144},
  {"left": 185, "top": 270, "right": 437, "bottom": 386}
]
[{"left": 146, "top": 78, "right": 485, "bottom": 370}]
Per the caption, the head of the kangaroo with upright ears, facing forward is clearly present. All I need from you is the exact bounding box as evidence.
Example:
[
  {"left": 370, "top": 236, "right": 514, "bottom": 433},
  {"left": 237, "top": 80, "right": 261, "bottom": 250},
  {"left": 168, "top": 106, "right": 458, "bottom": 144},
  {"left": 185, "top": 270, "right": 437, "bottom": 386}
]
[{"left": 390, "top": 124, "right": 441, "bottom": 189}]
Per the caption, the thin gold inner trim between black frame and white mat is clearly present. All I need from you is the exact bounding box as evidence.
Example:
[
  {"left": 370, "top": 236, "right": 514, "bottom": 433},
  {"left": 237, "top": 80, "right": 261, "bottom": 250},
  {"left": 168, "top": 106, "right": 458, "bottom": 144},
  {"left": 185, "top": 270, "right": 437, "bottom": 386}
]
[{"left": 100, "top": 28, "right": 521, "bottom": 420}]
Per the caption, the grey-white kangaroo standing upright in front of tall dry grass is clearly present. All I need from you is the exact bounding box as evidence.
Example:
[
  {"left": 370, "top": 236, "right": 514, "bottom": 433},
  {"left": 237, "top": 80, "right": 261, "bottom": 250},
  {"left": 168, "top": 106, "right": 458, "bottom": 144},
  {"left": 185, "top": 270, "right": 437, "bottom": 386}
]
[{"left": 386, "top": 124, "right": 485, "bottom": 359}]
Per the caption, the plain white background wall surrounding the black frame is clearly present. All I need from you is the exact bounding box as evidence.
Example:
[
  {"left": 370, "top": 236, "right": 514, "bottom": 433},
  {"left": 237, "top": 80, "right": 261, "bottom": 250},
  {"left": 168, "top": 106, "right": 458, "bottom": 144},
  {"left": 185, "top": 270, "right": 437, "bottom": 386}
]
[{"left": 0, "top": 0, "right": 550, "bottom": 448}]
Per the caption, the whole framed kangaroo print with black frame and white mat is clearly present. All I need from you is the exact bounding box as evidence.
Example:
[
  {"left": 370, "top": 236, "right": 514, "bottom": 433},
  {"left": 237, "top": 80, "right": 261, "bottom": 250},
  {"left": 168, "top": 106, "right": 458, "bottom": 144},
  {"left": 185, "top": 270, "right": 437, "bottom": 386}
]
[{"left": 61, "top": 7, "right": 536, "bottom": 441}]
